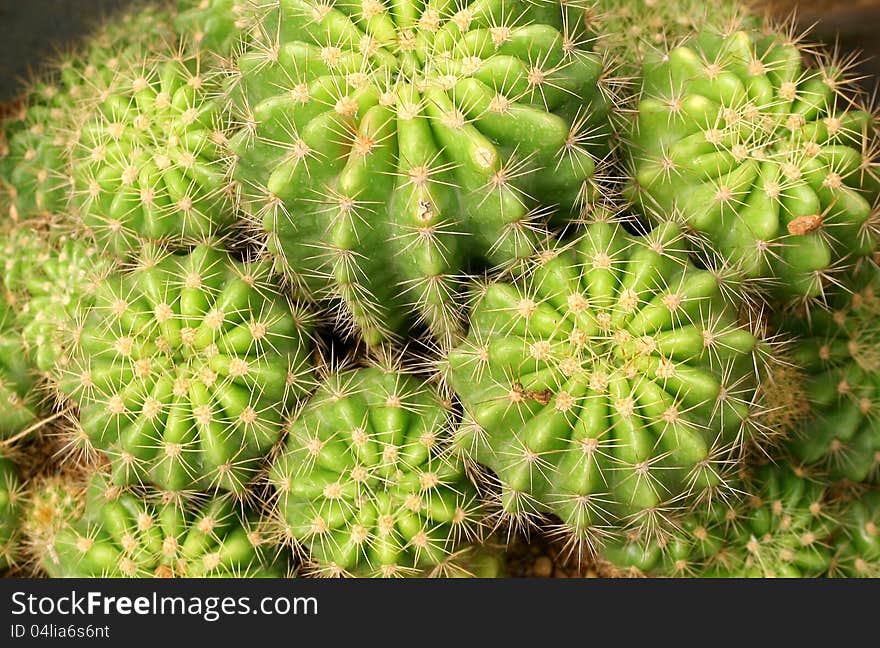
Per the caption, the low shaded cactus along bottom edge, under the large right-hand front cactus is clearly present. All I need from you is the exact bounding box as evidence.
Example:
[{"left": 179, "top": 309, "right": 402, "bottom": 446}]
[{"left": 602, "top": 466, "right": 837, "bottom": 578}]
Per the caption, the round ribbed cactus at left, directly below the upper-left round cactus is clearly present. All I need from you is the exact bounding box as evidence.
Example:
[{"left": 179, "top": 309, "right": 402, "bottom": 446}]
[{"left": 58, "top": 245, "right": 311, "bottom": 493}]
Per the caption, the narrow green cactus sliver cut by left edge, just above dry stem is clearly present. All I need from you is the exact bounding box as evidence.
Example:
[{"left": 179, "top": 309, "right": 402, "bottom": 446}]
[{"left": 0, "top": 294, "right": 38, "bottom": 440}]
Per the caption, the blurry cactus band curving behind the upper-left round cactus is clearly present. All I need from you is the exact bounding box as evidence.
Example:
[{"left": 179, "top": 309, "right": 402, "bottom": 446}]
[{"left": 0, "top": 3, "right": 177, "bottom": 220}]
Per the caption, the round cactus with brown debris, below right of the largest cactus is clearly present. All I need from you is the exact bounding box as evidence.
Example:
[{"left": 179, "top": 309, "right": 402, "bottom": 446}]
[{"left": 448, "top": 222, "right": 756, "bottom": 536}]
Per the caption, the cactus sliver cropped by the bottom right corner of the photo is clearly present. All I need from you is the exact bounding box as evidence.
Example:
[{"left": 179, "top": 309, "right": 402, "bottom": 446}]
[{"left": 832, "top": 491, "right": 880, "bottom": 578}]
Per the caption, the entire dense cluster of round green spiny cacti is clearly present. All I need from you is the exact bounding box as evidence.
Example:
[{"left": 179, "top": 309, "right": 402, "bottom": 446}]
[{"left": 0, "top": 0, "right": 880, "bottom": 578}]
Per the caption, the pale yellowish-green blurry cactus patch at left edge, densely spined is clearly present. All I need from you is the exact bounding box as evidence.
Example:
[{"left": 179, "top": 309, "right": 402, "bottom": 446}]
[{"left": 0, "top": 228, "right": 111, "bottom": 372}]
